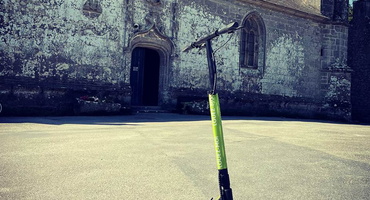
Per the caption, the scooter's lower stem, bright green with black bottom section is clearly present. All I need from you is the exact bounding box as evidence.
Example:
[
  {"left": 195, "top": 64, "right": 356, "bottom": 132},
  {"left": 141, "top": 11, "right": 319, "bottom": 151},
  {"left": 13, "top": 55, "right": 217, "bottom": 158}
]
[{"left": 208, "top": 94, "right": 233, "bottom": 200}]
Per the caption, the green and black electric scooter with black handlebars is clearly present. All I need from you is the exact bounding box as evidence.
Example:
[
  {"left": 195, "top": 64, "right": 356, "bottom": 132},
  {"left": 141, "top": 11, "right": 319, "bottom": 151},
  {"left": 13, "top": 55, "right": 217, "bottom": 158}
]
[{"left": 183, "top": 22, "right": 239, "bottom": 200}]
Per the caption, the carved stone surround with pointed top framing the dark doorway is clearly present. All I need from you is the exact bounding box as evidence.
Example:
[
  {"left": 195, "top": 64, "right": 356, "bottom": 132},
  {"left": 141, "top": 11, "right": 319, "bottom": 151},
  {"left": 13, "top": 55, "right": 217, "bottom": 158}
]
[{"left": 129, "top": 24, "right": 174, "bottom": 106}]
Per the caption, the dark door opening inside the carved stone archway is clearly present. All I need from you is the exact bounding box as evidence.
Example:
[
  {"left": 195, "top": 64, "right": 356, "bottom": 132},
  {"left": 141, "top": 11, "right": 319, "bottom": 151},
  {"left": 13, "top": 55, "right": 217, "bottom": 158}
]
[{"left": 130, "top": 47, "right": 160, "bottom": 106}]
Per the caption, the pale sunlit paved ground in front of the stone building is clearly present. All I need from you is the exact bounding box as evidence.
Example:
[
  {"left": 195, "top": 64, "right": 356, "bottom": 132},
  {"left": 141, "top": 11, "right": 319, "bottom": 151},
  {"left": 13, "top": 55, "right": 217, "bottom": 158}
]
[{"left": 0, "top": 114, "right": 370, "bottom": 200}]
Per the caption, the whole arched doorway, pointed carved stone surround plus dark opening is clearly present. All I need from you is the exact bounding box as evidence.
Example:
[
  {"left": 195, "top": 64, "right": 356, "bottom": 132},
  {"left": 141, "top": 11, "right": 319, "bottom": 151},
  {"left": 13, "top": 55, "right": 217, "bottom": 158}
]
[{"left": 127, "top": 24, "right": 174, "bottom": 107}]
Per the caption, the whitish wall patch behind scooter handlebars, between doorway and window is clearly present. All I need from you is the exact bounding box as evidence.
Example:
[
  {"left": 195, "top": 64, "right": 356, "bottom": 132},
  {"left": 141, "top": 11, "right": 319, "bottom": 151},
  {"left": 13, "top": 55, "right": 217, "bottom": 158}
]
[{"left": 173, "top": 2, "right": 241, "bottom": 91}]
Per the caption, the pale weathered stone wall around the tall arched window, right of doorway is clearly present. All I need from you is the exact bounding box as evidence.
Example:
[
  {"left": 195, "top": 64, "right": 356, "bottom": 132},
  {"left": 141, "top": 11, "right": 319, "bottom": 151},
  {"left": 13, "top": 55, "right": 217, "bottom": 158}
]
[{"left": 172, "top": 1, "right": 321, "bottom": 97}]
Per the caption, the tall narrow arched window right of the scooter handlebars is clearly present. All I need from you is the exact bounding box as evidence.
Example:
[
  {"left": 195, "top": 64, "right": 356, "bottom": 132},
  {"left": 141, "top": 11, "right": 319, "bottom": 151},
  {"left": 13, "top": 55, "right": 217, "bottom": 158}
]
[{"left": 240, "top": 12, "right": 266, "bottom": 69}]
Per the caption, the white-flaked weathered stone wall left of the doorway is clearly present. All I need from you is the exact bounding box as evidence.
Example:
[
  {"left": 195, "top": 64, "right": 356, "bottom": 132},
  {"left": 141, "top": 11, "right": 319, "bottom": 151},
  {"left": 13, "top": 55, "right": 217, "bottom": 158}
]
[{"left": 0, "top": 0, "right": 131, "bottom": 114}]
